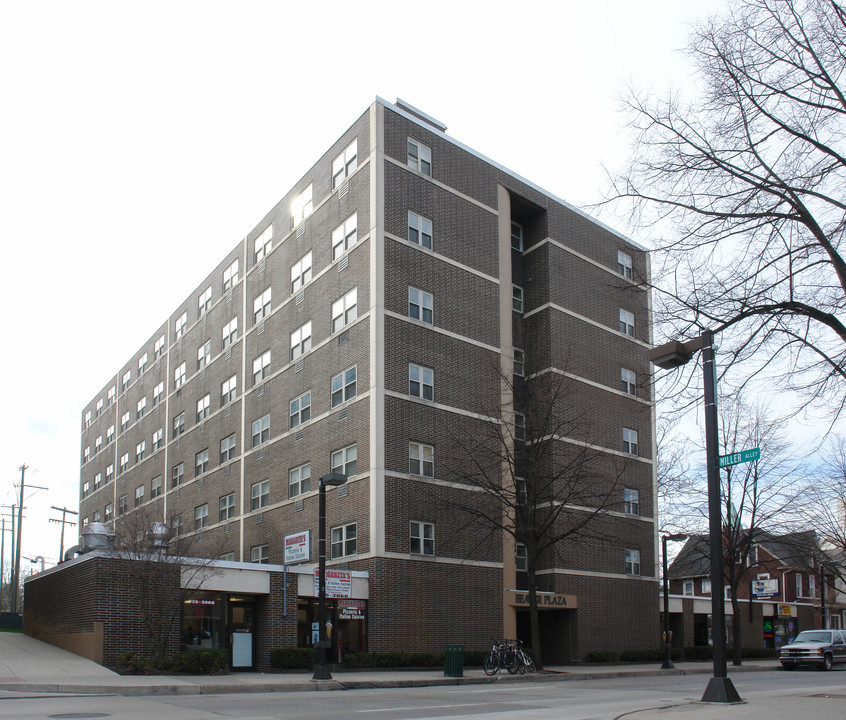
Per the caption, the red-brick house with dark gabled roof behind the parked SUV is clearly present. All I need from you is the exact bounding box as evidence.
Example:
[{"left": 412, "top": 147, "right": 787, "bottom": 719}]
[{"left": 661, "top": 531, "right": 841, "bottom": 648}]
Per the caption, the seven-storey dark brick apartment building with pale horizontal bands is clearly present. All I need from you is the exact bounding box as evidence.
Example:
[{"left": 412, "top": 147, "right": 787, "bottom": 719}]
[{"left": 80, "top": 99, "right": 658, "bottom": 662}]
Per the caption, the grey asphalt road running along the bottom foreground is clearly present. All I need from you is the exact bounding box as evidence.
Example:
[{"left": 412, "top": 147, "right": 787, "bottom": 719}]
[{"left": 0, "top": 668, "right": 846, "bottom": 720}]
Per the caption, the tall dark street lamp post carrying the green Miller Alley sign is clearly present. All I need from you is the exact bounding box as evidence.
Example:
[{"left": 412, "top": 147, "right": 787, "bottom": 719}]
[{"left": 649, "top": 330, "right": 741, "bottom": 702}]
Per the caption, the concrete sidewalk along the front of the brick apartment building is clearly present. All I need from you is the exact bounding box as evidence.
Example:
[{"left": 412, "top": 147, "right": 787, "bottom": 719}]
[{"left": 0, "top": 633, "right": 778, "bottom": 695}]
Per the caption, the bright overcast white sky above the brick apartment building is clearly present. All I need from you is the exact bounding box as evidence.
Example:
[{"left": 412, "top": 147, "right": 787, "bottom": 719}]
[{"left": 0, "top": 0, "right": 724, "bottom": 571}]
